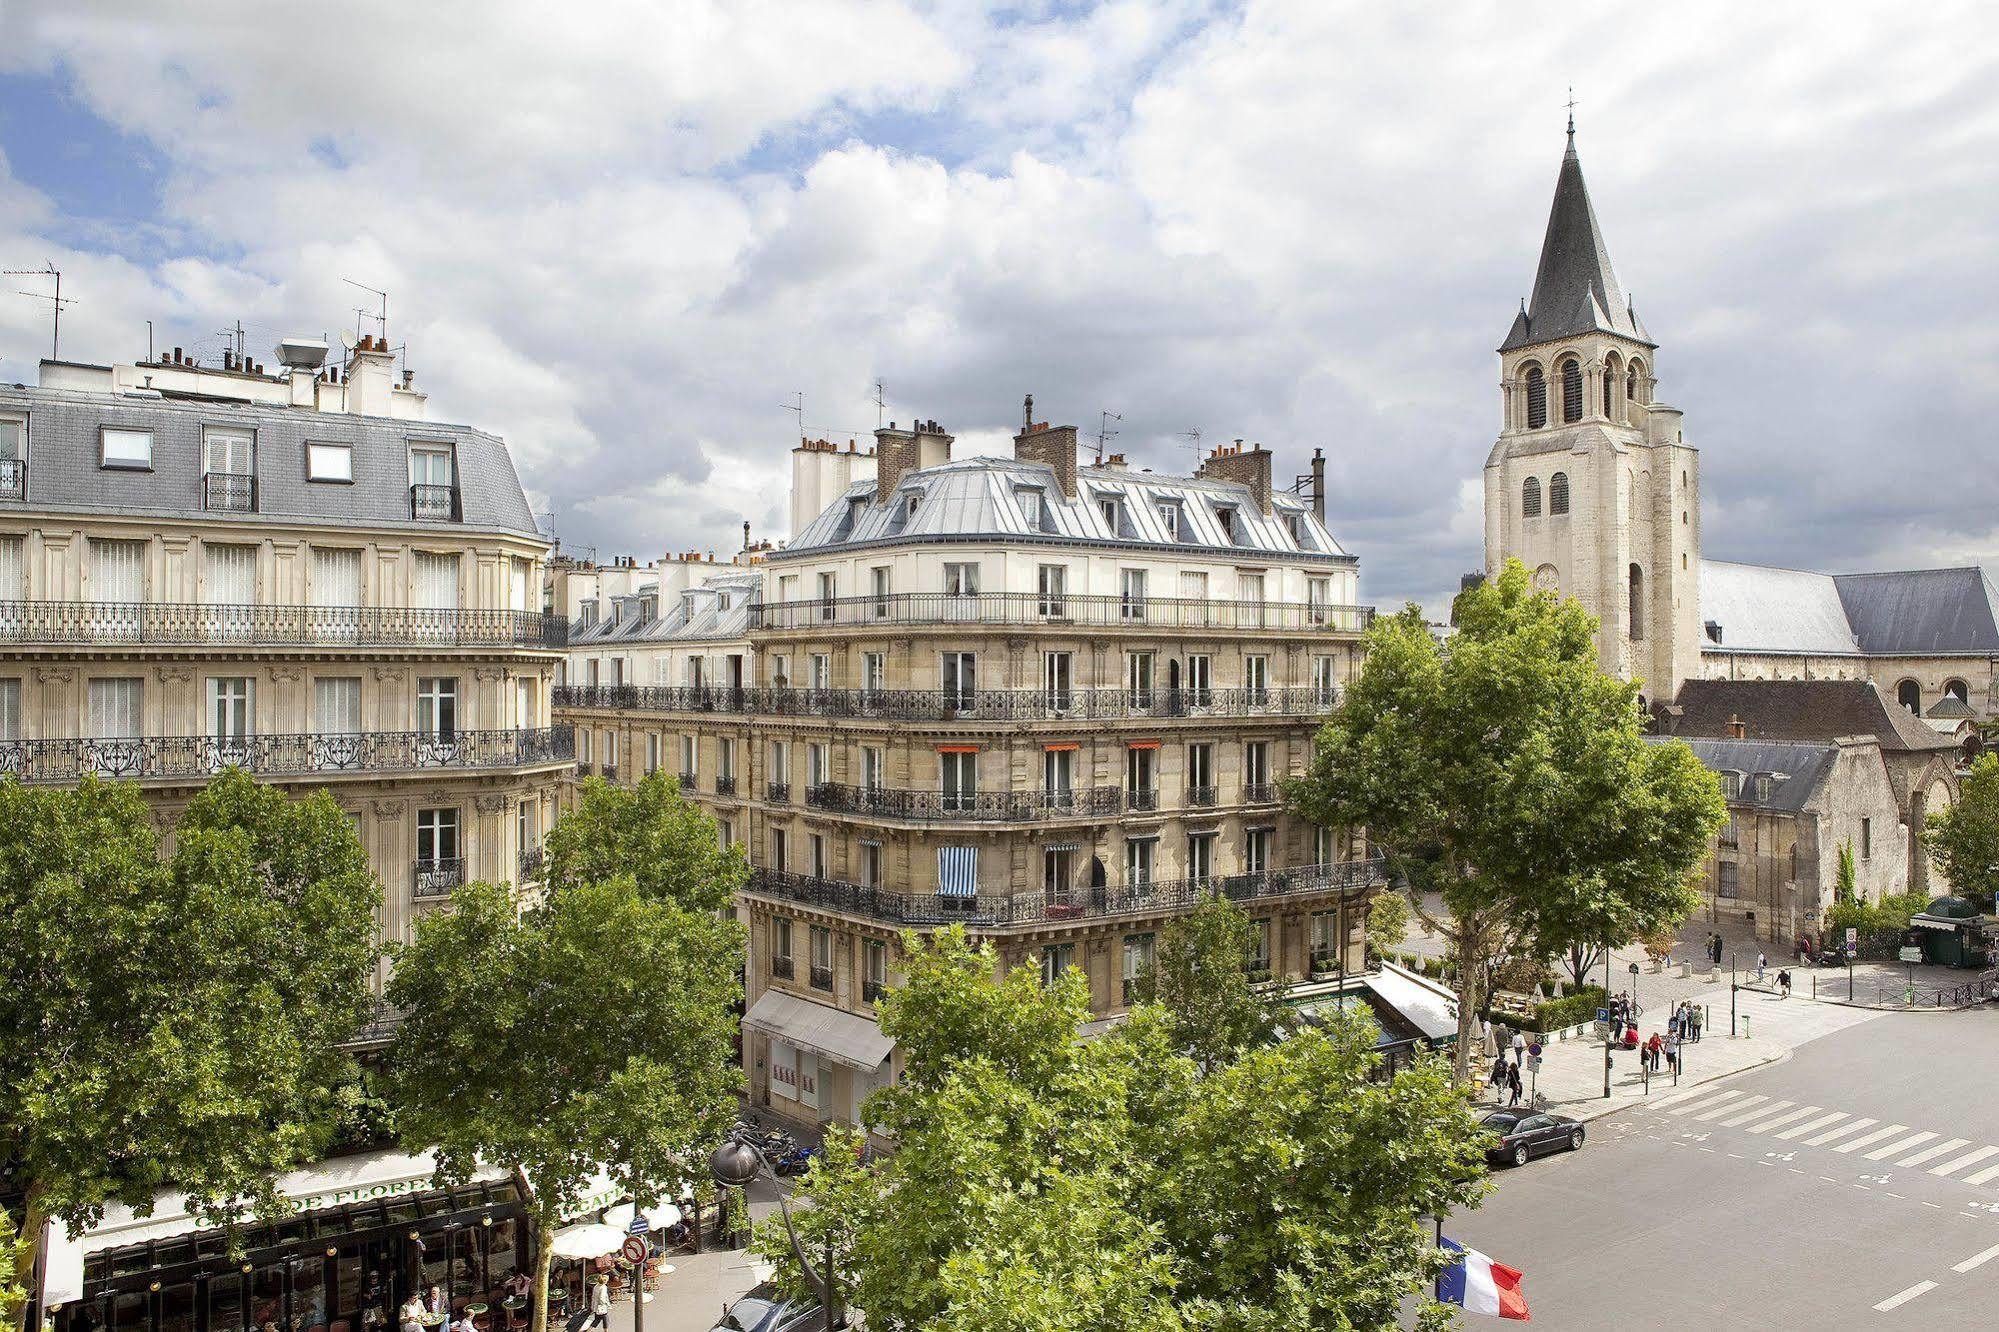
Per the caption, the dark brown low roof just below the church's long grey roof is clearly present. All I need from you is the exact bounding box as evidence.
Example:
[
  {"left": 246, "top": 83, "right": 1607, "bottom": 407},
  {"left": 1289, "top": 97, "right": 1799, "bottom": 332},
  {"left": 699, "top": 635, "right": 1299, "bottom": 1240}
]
[{"left": 1659, "top": 680, "right": 1957, "bottom": 752}]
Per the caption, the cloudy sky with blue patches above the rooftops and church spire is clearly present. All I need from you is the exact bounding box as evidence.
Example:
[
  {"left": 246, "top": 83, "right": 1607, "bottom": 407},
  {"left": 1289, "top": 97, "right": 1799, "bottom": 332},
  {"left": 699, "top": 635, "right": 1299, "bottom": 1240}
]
[{"left": 0, "top": 0, "right": 1999, "bottom": 608}]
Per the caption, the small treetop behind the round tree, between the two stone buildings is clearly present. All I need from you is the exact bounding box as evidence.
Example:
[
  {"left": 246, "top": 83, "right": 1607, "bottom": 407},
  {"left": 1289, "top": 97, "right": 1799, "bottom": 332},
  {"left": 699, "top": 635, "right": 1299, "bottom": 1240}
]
[{"left": 542, "top": 772, "right": 748, "bottom": 912}]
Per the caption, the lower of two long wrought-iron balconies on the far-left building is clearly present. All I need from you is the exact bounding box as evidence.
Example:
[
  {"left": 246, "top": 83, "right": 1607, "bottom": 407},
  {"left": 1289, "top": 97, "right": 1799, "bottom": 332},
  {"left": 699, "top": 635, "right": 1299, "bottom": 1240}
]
[{"left": 0, "top": 726, "right": 576, "bottom": 782}]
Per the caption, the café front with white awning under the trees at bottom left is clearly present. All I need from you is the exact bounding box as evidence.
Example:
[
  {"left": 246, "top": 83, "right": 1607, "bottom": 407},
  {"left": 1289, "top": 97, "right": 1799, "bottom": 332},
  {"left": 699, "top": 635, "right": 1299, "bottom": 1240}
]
[{"left": 30, "top": 1152, "right": 534, "bottom": 1332}]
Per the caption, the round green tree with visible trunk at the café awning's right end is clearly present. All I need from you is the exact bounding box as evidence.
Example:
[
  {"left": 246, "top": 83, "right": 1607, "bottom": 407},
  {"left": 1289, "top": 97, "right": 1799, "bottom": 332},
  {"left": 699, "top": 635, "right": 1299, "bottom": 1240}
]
[{"left": 390, "top": 876, "right": 744, "bottom": 1332}]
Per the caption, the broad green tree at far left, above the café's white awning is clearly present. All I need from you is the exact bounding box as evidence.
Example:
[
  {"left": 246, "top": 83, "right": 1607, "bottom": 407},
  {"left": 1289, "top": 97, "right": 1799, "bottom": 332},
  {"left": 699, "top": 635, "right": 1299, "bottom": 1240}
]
[{"left": 0, "top": 770, "right": 380, "bottom": 1236}]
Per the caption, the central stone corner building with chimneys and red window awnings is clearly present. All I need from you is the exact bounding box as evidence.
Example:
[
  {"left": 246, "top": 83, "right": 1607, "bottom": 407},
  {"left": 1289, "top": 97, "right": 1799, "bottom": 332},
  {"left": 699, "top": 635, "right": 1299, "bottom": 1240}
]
[{"left": 558, "top": 410, "right": 1379, "bottom": 1120}]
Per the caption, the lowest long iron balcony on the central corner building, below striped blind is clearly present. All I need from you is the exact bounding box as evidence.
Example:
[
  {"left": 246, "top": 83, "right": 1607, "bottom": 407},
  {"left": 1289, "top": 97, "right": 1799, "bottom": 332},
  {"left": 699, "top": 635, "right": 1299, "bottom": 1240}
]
[{"left": 744, "top": 860, "right": 1387, "bottom": 928}]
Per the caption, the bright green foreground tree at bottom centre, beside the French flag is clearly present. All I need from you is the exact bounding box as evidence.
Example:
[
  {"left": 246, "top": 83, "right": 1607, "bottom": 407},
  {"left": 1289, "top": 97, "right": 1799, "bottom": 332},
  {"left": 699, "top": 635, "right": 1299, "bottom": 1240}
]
[{"left": 756, "top": 930, "right": 1483, "bottom": 1332}]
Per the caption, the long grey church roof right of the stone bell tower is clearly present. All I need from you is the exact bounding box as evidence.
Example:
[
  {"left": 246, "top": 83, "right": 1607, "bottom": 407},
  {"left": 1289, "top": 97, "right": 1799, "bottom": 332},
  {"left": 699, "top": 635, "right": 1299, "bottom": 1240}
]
[{"left": 1701, "top": 560, "right": 1999, "bottom": 656}]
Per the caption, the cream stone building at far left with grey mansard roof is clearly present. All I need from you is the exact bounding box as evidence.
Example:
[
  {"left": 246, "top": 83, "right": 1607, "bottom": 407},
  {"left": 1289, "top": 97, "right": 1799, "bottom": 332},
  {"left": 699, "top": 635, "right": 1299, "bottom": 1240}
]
[{"left": 0, "top": 338, "right": 570, "bottom": 996}]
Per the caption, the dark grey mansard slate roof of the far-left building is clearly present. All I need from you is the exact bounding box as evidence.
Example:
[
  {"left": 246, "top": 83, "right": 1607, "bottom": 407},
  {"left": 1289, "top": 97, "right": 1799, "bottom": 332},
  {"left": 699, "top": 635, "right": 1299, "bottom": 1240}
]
[{"left": 0, "top": 386, "right": 546, "bottom": 540}]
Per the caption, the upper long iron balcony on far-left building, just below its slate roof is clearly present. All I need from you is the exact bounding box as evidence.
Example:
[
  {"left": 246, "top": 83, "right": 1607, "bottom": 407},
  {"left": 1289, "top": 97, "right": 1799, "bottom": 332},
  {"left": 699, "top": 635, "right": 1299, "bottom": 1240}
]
[{"left": 0, "top": 602, "right": 570, "bottom": 648}]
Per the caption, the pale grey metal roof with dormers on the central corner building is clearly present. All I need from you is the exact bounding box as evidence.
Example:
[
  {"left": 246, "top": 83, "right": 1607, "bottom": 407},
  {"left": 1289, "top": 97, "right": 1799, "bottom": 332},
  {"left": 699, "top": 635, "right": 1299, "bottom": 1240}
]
[{"left": 772, "top": 458, "right": 1353, "bottom": 562}]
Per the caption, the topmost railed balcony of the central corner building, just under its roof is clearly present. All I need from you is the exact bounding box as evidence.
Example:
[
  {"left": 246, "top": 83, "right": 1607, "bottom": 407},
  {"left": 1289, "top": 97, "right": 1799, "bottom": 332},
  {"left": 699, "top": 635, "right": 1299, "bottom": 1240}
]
[{"left": 750, "top": 592, "right": 1373, "bottom": 634}]
